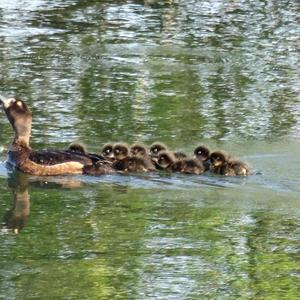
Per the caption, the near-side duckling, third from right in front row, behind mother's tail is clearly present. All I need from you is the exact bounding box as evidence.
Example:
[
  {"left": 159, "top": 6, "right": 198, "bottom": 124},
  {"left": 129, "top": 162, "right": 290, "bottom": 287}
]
[{"left": 113, "top": 143, "right": 156, "bottom": 172}]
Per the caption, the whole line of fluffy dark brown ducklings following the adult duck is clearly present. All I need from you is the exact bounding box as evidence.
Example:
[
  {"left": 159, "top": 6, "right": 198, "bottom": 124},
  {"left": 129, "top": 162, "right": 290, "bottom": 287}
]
[{"left": 68, "top": 142, "right": 251, "bottom": 176}]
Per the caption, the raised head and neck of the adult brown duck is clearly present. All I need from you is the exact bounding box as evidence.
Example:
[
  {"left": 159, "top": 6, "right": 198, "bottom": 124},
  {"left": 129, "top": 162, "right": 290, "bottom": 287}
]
[{"left": 0, "top": 96, "right": 32, "bottom": 145}]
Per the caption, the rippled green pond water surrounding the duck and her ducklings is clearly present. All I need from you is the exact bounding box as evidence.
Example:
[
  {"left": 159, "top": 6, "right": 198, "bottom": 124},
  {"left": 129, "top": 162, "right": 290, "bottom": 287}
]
[{"left": 0, "top": 0, "right": 300, "bottom": 299}]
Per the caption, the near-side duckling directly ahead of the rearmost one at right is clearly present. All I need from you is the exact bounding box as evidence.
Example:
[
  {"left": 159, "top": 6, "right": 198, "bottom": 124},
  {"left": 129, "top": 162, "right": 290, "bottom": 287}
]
[{"left": 158, "top": 151, "right": 204, "bottom": 175}]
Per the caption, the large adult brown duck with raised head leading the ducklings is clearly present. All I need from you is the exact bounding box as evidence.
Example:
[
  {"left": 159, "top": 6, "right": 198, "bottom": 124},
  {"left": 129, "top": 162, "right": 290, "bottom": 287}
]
[{"left": 0, "top": 96, "right": 113, "bottom": 176}]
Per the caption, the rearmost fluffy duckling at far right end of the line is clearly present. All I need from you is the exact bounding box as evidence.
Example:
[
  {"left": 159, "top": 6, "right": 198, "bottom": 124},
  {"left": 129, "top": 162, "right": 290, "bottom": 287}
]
[{"left": 210, "top": 150, "right": 251, "bottom": 176}]
